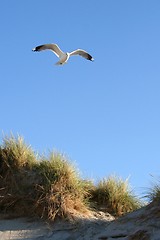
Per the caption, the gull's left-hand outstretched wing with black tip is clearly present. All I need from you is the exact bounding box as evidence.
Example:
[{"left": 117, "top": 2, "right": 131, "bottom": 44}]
[{"left": 32, "top": 43, "right": 64, "bottom": 57}]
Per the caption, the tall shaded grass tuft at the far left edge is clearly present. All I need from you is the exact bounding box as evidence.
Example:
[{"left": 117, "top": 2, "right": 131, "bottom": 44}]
[{"left": 0, "top": 136, "right": 37, "bottom": 216}]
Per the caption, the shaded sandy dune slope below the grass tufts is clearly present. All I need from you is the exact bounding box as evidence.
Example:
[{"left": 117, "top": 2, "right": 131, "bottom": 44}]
[{"left": 0, "top": 203, "right": 160, "bottom": 240}]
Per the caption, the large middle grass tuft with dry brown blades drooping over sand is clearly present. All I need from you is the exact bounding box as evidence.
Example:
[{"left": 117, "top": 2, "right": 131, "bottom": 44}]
[{"left": 34, "top": 153, "right": 88, "bottom": 220}]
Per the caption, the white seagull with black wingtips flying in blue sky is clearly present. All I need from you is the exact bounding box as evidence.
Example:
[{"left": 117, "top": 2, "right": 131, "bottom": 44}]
[{"left": 32, "top": 43, "right": 94, "bottom": 65}]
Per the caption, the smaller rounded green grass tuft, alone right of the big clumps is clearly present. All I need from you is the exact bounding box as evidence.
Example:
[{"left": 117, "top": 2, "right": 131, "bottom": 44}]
[{"left": 92, "top": 176, "right": 142, "bottom": 216}]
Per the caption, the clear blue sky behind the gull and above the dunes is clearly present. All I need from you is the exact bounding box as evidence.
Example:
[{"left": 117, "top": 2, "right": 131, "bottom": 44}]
[{"left": 0, "top": 0, "right": 160, "bottom": 195}]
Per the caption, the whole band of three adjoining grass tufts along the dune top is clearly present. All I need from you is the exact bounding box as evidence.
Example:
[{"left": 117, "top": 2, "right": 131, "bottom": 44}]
[{"left": 0, "top": 136, "right": 142, "bottom": 220}]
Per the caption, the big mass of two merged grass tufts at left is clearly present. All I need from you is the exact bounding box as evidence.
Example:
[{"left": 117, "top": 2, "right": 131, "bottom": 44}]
[{"left": 0, "top": 136, "right": 90, "bottom": 219}]
